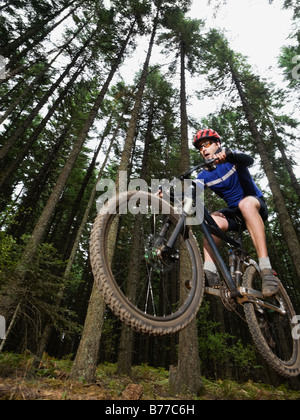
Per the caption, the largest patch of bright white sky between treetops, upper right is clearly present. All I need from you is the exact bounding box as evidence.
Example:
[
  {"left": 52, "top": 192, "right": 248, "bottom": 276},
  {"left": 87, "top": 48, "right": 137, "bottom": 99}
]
[{"left": 190, "top": 0, "right": 293, "bottom": 76}]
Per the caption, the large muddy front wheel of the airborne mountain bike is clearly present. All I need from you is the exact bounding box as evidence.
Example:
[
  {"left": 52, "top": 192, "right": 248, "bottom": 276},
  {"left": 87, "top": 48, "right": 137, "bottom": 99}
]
[{"left": 90, "top": 191, "right": 204, "bottom": 335}]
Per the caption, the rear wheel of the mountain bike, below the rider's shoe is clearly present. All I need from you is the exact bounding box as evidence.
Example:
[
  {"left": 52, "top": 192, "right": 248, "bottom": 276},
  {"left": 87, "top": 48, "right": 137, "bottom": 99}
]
[{"left": 243, "top": 266, "right": 300, "bottom": 378}]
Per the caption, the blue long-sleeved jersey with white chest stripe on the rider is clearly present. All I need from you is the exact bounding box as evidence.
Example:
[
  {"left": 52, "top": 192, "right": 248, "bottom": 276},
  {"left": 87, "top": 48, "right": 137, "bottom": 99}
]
[{"left": 197, "top": 151, "right": 263, "bottom": 208}]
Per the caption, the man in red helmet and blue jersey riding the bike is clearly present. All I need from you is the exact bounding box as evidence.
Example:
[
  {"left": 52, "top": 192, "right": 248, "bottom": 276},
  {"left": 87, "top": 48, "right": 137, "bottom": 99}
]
[{"left": 194, "top": 129, "right": 279, "bottom": 297}]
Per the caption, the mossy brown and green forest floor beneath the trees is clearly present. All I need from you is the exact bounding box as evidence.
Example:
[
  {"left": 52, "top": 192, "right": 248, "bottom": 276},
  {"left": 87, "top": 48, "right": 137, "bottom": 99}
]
[{"left": 0, "top": 353, "right": 300, "bottom": 401}]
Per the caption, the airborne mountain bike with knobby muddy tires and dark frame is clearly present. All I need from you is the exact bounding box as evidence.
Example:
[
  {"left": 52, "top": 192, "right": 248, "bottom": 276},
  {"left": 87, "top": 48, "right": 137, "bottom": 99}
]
[{"left": 90, "top": 161, "right": 300, "bottom": 377}]
